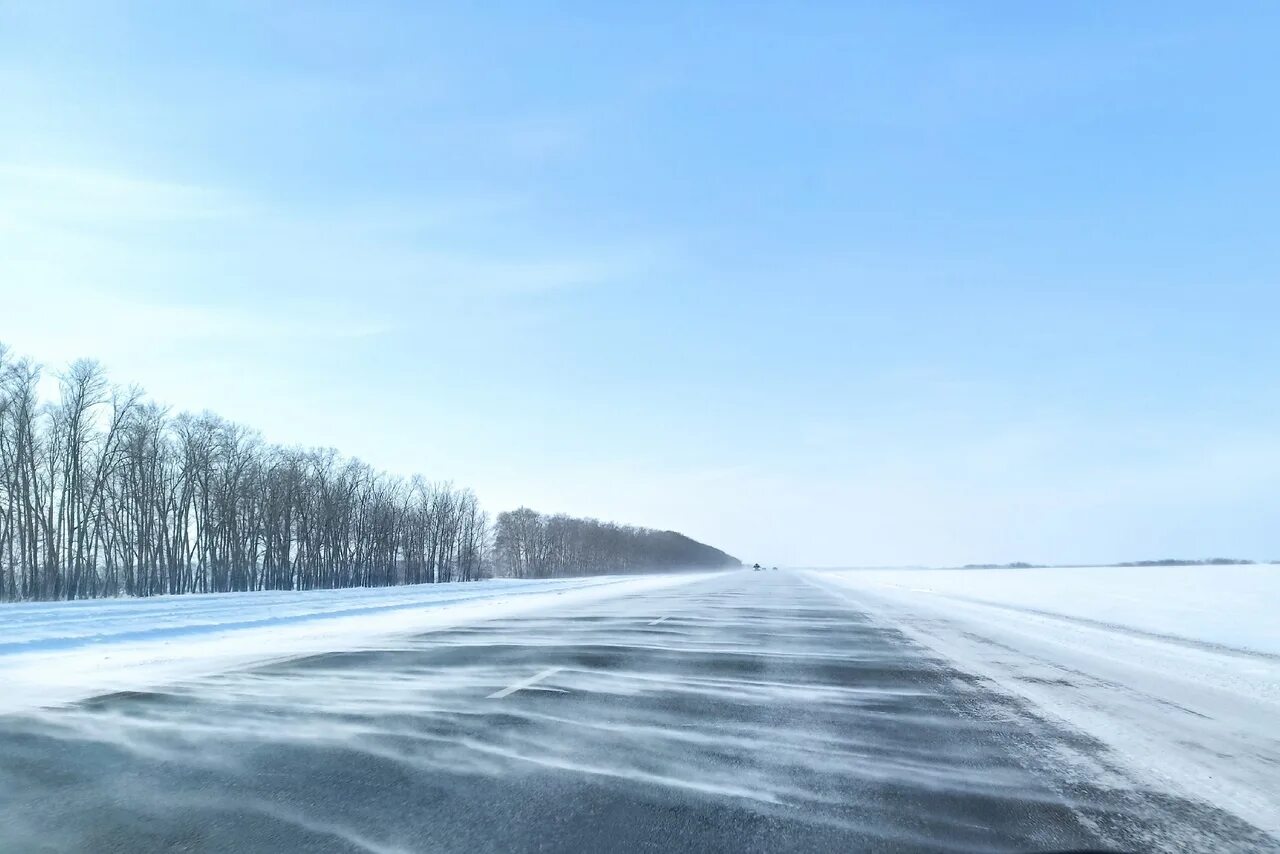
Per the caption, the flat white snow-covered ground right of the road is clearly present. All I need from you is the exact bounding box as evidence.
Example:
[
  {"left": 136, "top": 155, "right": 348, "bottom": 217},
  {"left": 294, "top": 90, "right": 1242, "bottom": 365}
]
[{"left": 805, "top": 567, "right": 1280, "bottom": 836}]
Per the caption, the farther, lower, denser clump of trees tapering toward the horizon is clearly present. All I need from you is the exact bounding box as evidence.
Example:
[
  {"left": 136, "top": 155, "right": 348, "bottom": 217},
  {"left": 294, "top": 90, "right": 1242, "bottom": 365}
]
[{"left": 494, "top": 507, "right": 740, "bottom": 579}]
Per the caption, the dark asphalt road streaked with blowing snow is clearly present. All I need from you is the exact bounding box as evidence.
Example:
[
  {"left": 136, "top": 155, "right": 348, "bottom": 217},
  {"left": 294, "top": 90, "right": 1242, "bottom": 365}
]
[{"left": 0, "top": 571, "right": 1267, "bottom": 853}]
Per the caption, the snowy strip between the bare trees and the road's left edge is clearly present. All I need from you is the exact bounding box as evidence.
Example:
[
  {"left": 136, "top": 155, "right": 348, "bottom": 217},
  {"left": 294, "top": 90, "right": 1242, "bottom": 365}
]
[{"left": 0, "top": 572, "right": 714, "bottom": 714}]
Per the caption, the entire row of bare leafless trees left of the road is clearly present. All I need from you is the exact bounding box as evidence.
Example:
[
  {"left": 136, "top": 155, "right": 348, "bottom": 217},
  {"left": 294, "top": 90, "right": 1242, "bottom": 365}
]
[{"left": 0, "top": 346, "right": 737, "bottom": 600}]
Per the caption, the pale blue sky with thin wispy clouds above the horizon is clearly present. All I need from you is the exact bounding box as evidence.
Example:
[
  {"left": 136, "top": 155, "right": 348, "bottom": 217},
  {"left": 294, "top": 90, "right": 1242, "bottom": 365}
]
[{"left": 0, "top": 0, "right": 1280, "bottom": 566}]
